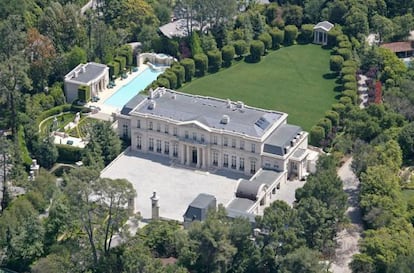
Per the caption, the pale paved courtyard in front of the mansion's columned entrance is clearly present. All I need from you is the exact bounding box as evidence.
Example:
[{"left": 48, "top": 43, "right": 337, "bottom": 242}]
[{"left": 101, "top": 151, "right": 246, "bottom": 221}]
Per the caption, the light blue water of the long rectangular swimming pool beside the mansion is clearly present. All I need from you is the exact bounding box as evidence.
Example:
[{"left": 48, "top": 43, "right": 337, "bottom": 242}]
[{"left": 104, "top": 68, "right": 162, "bottom": 109}]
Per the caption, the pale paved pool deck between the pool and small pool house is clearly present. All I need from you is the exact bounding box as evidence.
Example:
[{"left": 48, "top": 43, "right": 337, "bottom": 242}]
[{"left": 86, "top": 64, "right": 149, "bottom": 116}]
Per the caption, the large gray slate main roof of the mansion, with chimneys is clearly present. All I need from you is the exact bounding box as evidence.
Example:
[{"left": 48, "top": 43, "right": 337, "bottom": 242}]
[{"left": 128, "top": 89, "right": 283, "bottom": 137}]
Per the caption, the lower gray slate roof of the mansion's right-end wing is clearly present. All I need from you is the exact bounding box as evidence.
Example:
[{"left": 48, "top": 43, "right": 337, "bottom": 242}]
[{"left": 263, "top": 124, "right": 302, "bottom": 156}]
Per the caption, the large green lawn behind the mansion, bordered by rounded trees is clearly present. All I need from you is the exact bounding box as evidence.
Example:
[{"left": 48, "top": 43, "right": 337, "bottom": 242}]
[{"left": 180, "top": 45, "right": 336, "bottom": 131}]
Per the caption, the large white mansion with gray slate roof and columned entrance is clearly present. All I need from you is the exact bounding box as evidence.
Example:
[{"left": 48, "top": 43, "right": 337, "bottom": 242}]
[{"left": 116, "top": 88, "right": 314, "bottom": 179}]
